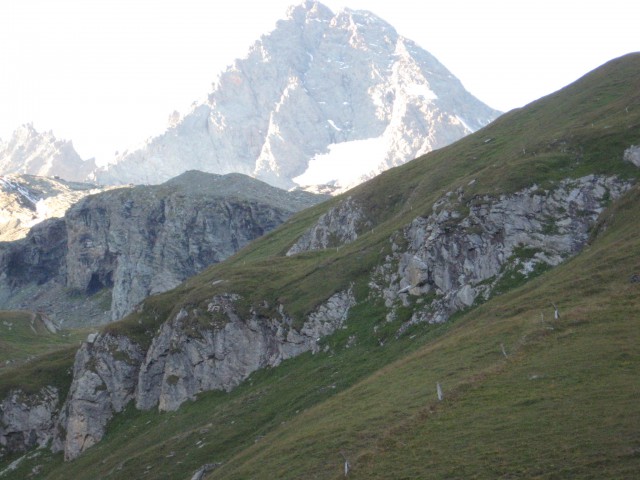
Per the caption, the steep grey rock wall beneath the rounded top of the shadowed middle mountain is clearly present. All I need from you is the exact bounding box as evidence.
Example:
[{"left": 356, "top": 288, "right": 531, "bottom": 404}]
[{"left": 66, "top": 190, "right": 291, "bottom": 320}]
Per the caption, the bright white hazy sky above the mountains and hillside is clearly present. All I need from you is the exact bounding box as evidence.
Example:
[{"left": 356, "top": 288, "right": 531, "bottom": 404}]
[{"left": 0, "top": 0, "right": 640, "bottom": 161}]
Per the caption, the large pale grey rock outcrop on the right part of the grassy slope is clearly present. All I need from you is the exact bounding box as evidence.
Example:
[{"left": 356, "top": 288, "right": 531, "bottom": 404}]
[{"left": 372, "top": 175, "right": 630, "bottom": 327}]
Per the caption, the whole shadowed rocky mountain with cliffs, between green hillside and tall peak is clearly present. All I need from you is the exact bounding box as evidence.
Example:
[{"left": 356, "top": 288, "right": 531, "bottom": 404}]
[{"left": 0, "top": 173, "right": 321, "bottom": 324}]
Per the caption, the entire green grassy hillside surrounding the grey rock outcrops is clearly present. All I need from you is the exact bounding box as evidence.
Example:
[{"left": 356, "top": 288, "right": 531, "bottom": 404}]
[{"left": 0, "top": 54, "right": 640, "bottom": 479}]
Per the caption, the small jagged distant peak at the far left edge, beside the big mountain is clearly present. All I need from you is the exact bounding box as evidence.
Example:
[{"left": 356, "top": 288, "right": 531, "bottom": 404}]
[{"left": 0, "top": 124, "right": 96, "bottom": 181}]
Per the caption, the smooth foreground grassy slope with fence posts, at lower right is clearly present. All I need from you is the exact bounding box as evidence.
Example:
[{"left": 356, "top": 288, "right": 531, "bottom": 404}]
[{"left": 211, "top": 188, "right": 640, "bottom": 479}]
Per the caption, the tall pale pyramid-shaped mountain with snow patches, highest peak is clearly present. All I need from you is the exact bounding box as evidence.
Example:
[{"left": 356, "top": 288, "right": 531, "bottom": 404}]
[{"left": 97, "top": 1, "right": 499, "bottom": 188}]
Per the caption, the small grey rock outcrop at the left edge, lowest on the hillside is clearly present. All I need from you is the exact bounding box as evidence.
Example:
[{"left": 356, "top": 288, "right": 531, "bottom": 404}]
[{"left": 0, "top": 386, "right": 60, "bottom": 457}]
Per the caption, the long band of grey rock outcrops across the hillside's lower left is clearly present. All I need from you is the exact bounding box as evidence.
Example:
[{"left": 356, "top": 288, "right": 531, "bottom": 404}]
[{"left": 0, "top": 290, "right": 355, "bottom": 460}]
